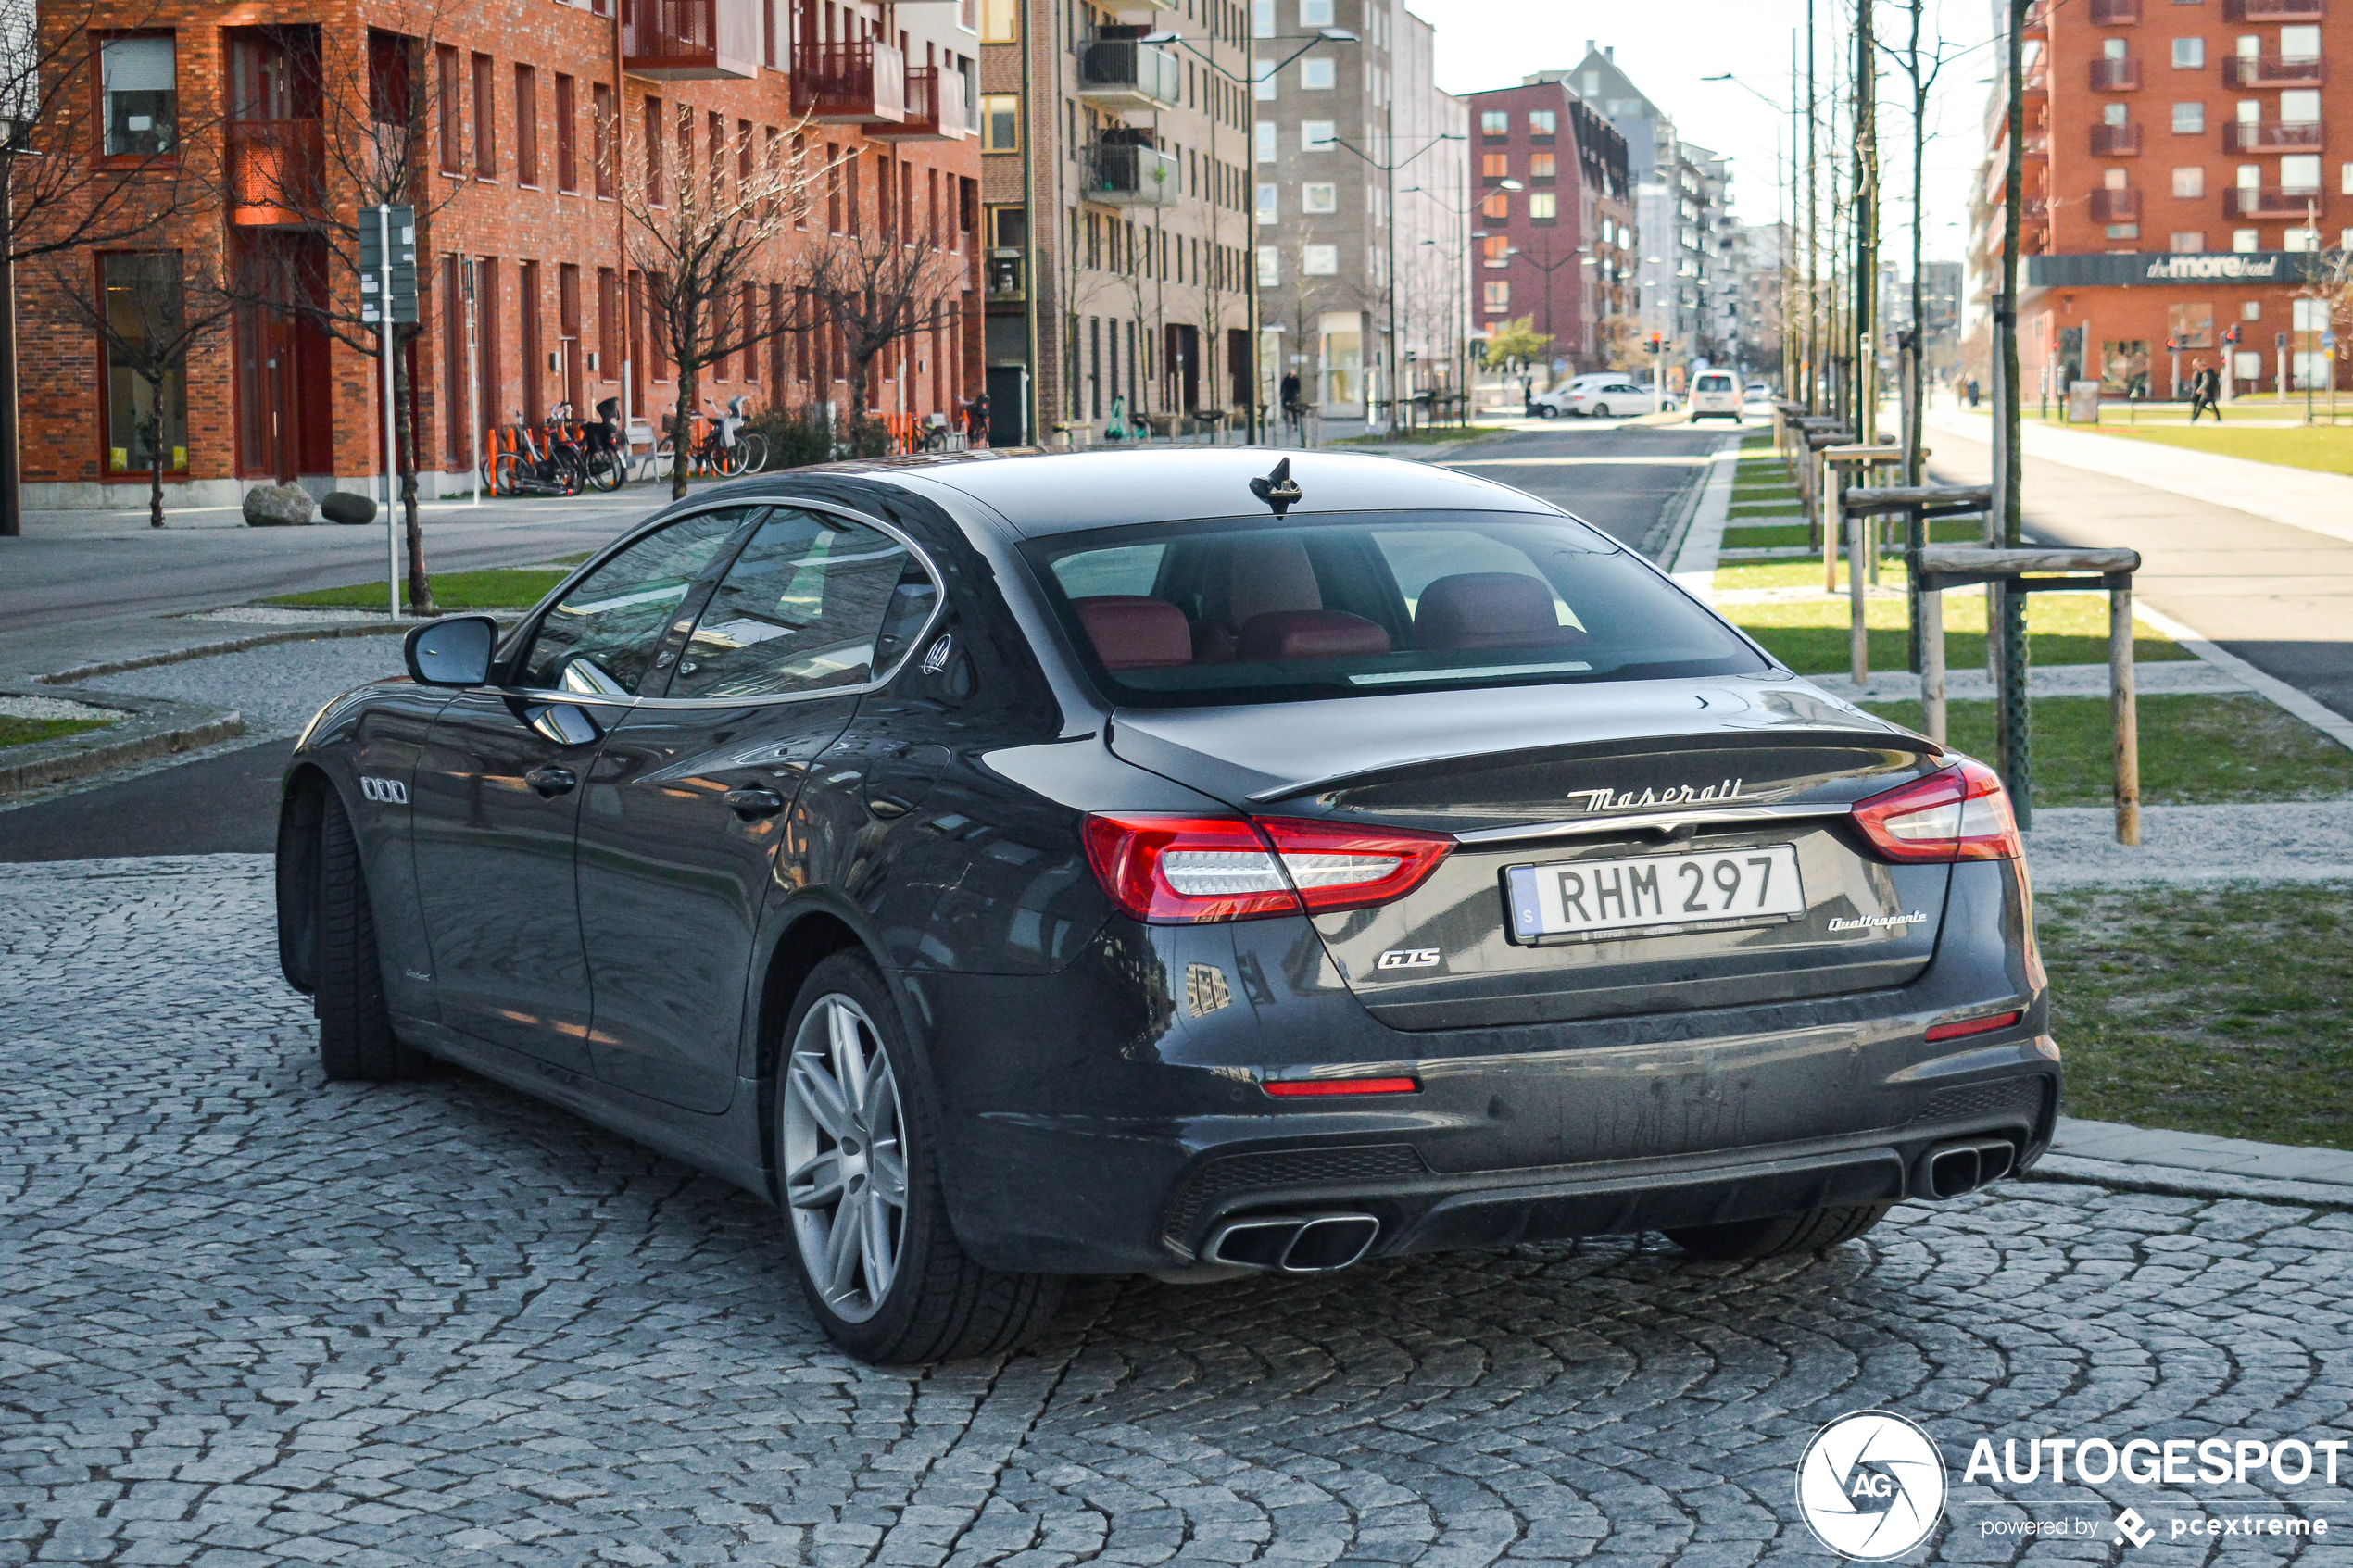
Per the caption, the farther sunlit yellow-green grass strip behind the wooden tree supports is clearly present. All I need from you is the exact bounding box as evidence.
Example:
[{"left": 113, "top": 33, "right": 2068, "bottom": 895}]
[{"left": 1716, "top": 583, "right": 2191, "bottom": 674}]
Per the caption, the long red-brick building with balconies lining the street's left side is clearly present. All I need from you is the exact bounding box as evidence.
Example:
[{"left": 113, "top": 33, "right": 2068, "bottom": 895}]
[{"left": 19, "top": 0, "right": 981, "bottom": 506}]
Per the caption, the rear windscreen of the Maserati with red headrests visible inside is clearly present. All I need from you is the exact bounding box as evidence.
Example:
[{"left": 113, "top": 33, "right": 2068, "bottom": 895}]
[{"left": 1024, "top": 512, "right": 1769, "bottom": 708}]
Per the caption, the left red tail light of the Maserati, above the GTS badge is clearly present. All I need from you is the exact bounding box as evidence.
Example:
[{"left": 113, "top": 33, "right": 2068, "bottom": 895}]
[{"left": 1085, "top": 816, "right": 1454, "bottom": 924}]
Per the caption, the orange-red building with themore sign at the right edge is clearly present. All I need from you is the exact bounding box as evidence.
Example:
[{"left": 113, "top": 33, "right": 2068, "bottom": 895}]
[{"left": 1972, "top": 0, "right": 2353, "bottom": 399}]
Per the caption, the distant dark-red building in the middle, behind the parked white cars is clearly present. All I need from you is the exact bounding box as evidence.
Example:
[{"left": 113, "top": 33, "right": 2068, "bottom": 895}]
[{"left": 1464, "top": 70, "right": 1640, "bottom": 371}]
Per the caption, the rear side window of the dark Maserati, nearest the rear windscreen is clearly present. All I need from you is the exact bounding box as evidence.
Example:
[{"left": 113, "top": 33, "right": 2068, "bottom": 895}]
[{"left": 668, "top": 508, "right": 937, "bottom": 698}]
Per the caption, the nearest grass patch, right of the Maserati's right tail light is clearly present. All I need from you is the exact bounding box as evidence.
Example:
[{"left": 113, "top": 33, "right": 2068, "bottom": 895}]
[{"left": 2035, "top": 886, "right": 2353, "bottom": 1149}]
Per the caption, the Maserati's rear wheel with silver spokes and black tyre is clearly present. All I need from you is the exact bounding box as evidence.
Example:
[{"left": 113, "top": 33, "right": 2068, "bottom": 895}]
[{"left": 772, "top": 952, "right": 1062, "bottom": 1361}]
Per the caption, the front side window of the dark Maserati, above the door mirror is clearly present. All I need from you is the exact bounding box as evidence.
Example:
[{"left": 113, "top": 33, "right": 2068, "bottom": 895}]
[{"left": 515, "top": 506, "right": 753, "bottom": 696}]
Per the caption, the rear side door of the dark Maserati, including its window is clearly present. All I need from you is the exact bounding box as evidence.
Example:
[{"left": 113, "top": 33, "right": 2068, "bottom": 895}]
[{"left": 579, "top": 508, "right": 938, "bottom": 1112}]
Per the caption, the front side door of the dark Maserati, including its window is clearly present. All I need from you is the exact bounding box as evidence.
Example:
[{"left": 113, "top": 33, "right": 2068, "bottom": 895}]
[{"left": 409, "top": 512, "right": 744, "bottom": 1074}]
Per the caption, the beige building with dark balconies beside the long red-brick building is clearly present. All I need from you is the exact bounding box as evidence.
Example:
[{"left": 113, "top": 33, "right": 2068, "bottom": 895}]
[{"left": 981, "top": 0, "right": 1261, "bottom": 445}]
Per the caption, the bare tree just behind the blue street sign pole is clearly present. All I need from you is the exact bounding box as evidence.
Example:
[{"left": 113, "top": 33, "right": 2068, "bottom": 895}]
[{"left": 221, "top": 12, "right": 466, "bottom": 616}]
